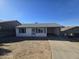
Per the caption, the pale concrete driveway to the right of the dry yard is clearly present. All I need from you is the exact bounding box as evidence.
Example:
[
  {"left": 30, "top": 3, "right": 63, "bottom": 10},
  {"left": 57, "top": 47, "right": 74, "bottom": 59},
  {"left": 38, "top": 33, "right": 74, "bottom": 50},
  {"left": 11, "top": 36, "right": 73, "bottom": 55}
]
[{"left": 49, "top": 40, "right": 79, "bottom": 59}]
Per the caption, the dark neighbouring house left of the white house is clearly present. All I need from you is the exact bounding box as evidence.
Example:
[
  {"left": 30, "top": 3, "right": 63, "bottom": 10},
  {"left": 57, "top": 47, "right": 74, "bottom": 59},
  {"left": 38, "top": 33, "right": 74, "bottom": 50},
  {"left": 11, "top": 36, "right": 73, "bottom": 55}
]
[{"left": 0, "top": 20, "right": 21, "bottom": 37}]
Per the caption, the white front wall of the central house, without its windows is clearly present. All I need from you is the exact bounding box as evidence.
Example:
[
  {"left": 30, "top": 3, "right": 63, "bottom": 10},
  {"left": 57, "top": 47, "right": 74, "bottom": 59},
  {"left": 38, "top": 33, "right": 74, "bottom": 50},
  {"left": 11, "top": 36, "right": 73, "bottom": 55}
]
[{"left": 16, "top": 28, "right": 47, "bottom": 37}]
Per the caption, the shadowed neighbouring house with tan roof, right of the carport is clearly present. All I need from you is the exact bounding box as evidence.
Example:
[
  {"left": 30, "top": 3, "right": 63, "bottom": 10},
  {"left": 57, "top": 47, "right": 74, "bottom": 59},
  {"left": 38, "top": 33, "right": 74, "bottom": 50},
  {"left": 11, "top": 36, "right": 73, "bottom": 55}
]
[{"left": 61, "top": 26, "right": 79, "bottom": 37}]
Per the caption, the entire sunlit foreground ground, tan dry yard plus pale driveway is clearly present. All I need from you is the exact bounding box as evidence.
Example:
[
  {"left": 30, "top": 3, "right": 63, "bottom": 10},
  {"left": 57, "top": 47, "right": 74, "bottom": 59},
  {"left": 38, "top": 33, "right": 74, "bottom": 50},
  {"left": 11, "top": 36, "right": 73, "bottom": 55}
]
[{"left": 0, "top": 40, "right": 79, "bottom": 59}]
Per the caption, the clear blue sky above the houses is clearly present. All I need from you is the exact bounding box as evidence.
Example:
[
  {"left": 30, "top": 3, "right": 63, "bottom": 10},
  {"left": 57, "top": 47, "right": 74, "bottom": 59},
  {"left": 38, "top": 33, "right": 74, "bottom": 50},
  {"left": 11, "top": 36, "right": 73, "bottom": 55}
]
[{"left": 0, "top": 0, "right": 79, "bottom": 26}]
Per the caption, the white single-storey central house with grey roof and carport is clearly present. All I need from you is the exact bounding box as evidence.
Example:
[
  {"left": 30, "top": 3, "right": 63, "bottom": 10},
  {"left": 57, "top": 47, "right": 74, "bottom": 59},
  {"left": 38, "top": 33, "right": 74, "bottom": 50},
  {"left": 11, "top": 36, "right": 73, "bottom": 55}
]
[{"left": 16, "top": 23, "right": 61, "bottom": 37}]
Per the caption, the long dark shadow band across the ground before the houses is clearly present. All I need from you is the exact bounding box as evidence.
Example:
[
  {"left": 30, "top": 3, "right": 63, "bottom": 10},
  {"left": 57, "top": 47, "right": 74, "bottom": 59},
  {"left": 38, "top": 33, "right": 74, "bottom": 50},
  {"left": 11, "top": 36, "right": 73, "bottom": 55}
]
[{"left": 0, "top": 37, "right": 79, "bottom": 43}]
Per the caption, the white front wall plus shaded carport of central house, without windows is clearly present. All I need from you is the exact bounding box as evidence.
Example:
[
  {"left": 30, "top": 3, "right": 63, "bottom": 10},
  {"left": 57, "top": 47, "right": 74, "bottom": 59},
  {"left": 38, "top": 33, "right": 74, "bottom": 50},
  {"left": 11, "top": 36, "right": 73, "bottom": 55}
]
[{"left": 16, "top": 27, "right": 60, "bottom": 37}]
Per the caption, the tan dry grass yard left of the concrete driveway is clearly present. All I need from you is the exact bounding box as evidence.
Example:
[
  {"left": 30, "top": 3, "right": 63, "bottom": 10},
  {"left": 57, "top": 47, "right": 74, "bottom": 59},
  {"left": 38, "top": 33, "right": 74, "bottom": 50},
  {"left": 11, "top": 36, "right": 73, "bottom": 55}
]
[{"left": 0, "top": 40, "right": 51, "bottom": 59}]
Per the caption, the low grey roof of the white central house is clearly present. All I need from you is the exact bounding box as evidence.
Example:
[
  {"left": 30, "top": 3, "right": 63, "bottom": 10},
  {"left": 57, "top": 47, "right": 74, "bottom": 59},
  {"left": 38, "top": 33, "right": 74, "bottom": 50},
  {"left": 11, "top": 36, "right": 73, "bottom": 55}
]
[{"left": 17, "top": 23, "right": 61, "bottom": 27}]
